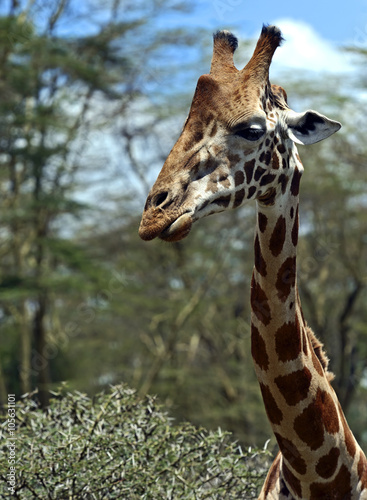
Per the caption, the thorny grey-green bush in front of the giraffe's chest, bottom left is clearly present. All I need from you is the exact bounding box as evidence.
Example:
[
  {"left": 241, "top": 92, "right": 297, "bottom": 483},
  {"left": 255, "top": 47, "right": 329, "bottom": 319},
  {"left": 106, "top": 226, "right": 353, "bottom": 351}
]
[{"left": 0, "top": 385, "right": 268, "bottom": 500}]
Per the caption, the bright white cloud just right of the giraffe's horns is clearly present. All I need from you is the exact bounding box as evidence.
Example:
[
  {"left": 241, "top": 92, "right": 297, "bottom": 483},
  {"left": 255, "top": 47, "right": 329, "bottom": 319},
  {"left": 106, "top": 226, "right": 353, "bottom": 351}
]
[{"left": 266, "top": 19, "right": 353, "bottom": 74}]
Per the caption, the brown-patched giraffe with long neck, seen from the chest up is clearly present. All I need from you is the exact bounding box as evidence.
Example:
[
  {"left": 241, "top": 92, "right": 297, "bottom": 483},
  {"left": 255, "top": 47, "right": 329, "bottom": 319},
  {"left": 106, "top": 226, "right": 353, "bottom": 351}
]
[{"left": 139, "top": 25, "right": 367, "bottom": 500}]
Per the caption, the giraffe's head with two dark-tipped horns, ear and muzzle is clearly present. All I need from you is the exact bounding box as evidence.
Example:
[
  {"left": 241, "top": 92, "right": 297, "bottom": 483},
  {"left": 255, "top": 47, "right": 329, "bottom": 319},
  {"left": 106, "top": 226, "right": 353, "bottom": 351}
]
[{"left": 139, "top": 26, "right": 340, "bottom": 241}]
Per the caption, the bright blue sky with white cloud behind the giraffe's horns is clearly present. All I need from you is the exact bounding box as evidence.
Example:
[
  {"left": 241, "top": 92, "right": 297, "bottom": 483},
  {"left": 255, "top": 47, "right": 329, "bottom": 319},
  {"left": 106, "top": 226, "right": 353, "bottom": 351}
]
[{"left": 150, "top": 0, "right": 367, "bottom": 74}]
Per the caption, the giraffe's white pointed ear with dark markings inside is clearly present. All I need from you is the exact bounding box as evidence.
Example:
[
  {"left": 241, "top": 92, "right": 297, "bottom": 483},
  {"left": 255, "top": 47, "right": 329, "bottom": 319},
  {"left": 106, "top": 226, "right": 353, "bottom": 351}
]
[{"left": 286, "top": 109, "right": 341, "bottom": 145}]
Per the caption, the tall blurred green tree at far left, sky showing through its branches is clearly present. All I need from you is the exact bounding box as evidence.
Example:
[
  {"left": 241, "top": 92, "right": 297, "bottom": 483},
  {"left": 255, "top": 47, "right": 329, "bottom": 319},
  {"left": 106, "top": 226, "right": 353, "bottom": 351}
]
[{"left": 0, "top": 0, "right": 200, "bottom": 406}]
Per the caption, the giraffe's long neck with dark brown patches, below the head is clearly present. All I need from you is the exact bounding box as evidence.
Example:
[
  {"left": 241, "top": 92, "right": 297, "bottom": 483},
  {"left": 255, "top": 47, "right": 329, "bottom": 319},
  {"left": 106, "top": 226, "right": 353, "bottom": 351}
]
[{"left": 251, "top": 167, "right": 367, "bottom": 499}]
